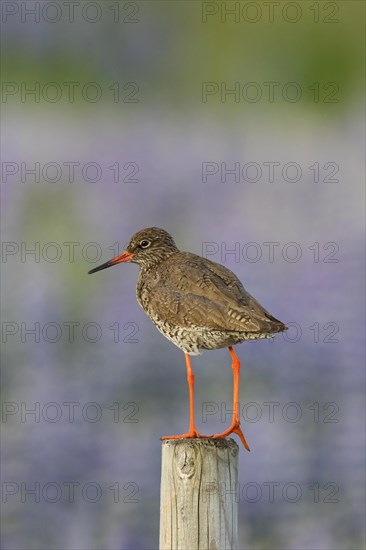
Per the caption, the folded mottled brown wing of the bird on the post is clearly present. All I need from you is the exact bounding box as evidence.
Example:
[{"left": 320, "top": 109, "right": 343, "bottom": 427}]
[{"left": 149, "top": 252, "right": 282, "bottom": 332}]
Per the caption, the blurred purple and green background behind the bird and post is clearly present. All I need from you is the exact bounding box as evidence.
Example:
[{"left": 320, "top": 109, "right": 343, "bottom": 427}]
[{"left": 1, "top": 0, "right": 365, "bottom": 550}]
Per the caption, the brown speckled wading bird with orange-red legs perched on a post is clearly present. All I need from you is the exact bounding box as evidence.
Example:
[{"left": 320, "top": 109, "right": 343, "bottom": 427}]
[{"left": 89, "top": 227, "right": 287, "bottom": 451}]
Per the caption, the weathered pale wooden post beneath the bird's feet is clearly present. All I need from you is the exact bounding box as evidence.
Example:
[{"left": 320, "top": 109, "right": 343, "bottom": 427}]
[{"left": 160, "top": 438, "right": 239, "bottom": 550}]
